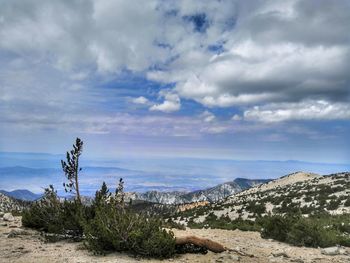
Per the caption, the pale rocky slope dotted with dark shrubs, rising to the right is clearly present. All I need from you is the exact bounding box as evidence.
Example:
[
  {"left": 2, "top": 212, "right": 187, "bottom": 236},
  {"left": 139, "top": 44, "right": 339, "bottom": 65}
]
[{"left": 177, "top": 172, "right": 350, "bottom": 223}]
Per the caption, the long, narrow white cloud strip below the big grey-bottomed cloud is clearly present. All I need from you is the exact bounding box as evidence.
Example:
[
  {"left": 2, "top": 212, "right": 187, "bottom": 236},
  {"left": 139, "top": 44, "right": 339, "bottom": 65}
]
[{"left": 244, "top": 100, "right": 350, "bottom": 122}]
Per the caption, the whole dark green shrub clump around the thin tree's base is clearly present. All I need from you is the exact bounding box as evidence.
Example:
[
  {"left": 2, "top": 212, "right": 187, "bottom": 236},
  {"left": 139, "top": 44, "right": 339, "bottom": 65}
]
[{"left": 22, "top": 183, "right": 175, "bottom": 258}]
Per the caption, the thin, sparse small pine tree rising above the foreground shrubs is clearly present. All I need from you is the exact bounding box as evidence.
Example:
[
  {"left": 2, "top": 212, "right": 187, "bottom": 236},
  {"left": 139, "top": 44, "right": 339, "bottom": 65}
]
[{"left": 61, "top": 138, "right": 83, "bottom": 203}]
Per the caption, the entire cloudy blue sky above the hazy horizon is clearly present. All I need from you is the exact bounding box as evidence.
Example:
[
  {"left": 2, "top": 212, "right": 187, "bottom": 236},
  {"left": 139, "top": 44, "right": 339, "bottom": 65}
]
[{"left": 0, "top": 0, "right": 350, "bottom": 164}]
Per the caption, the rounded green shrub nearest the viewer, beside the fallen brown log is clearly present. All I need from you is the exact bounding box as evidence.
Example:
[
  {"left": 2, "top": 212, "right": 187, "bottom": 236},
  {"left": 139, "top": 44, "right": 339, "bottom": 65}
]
[{"left": 84, "top": 198, "right": 175, "bottom": 258}]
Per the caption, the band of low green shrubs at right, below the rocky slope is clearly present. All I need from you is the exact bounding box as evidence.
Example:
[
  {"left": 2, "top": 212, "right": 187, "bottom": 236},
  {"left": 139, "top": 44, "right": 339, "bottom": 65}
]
[{"left": 182, "top": 213, "right": 350, "bottom": 247}]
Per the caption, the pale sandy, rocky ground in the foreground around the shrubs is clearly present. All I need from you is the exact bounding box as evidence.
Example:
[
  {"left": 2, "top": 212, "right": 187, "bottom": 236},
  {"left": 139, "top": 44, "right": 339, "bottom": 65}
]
[{"left": 0, "top": 217, "right": 350, "bottom": 263}]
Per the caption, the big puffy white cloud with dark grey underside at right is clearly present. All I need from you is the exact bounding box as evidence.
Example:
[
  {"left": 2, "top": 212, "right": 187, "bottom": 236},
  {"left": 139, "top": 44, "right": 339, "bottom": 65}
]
[{"left": 176, "top": 41, "right": 349, "bottom": 107}]
